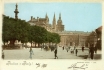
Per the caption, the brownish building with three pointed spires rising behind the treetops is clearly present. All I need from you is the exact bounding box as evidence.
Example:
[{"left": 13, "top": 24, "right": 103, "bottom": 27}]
[{"left": 28, "top": 14, "right": 64, "bottom": 32}]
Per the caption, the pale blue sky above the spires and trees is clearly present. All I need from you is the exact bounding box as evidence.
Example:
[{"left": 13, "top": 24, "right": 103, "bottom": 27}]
[{"left": 4, "top": 3, "right": 102, "bottom": 32}]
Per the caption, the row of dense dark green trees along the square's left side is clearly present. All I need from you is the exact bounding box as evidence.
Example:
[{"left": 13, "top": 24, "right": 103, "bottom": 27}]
[{"left": 2, "top": 15, "right": 60, "bottom": 48}]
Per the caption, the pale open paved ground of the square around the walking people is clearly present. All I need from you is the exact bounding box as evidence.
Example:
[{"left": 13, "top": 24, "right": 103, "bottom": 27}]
[{"left": 4, "top": 47, "right": 101, "bottom": 60}]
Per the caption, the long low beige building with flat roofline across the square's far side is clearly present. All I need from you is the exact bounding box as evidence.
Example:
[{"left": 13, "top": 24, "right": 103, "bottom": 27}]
[{"left": 58, "top": 31, "right": 91, "bottom": 47}]
